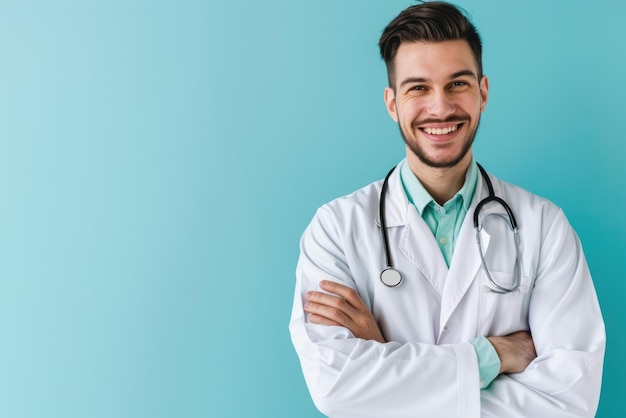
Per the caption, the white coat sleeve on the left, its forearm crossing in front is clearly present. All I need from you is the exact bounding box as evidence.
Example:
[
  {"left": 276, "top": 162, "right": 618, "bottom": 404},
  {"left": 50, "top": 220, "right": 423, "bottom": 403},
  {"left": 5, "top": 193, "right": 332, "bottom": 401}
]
[{"left": 290, "top": 208, "right": 480, "bottom": 418}]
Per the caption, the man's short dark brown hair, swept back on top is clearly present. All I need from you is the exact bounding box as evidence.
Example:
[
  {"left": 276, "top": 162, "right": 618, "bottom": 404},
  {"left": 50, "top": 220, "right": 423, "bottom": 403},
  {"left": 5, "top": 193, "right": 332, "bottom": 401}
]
[{"left": 378, "top": 1, "right": 483, "bottom": 89}]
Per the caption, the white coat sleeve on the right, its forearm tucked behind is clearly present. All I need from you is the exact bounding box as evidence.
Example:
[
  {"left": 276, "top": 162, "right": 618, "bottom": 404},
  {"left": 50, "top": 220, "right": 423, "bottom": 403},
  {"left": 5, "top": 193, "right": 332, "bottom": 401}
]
[{"left": 481, "top": 210, "right": 605, "bottom": 418}]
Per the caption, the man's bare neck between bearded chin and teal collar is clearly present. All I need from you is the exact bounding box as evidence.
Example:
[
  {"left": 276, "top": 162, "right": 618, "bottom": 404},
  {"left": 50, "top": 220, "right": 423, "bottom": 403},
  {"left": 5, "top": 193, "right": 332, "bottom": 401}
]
[{"left": 407, "top": 151, "right": 472, "bottom": 205}]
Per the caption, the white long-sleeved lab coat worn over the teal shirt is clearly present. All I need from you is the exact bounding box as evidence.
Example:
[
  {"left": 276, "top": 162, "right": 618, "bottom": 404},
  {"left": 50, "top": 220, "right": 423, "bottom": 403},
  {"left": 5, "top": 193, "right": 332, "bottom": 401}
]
[{"left": 289, "top": 165, "right": 605, "bottom": 418}]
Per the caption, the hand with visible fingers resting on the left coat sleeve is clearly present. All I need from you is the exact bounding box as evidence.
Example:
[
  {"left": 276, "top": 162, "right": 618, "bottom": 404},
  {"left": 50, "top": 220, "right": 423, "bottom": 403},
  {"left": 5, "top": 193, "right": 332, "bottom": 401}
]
[{"left": 304, "top": 280, "right": 385, "bottom": 343}]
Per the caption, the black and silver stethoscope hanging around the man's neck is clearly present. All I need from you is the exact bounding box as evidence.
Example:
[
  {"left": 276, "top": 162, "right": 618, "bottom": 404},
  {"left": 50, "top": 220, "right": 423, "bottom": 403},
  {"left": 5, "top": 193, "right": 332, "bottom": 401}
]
[{"left": 379, "top": 164, "right": 528, "bottom": 294}]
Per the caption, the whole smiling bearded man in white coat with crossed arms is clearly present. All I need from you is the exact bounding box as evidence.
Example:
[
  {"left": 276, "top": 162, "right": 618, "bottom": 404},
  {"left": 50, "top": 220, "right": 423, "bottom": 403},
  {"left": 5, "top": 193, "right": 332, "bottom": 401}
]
[{"left": 290, "top": 2, "right": 605, "bottom": 418}]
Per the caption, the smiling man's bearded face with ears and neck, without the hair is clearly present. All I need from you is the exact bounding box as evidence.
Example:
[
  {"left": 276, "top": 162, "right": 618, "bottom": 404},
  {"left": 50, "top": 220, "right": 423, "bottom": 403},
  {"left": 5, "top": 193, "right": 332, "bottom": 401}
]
[{"left": 385, "top": 40, "right": 488, "bottom": 203}]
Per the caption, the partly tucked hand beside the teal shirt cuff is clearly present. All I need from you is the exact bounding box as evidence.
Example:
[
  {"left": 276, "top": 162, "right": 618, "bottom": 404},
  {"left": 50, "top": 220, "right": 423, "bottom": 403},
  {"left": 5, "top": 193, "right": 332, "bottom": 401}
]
[{"left": 487, "top": 331, "right": 537, "bottom": 374}]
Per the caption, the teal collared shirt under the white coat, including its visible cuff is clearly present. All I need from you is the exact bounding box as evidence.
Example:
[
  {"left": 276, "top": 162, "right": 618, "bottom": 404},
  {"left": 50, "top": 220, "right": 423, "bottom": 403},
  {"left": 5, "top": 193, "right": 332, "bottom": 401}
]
[{"left": 400, "top": 160, "right": 500, "bottom": 389}]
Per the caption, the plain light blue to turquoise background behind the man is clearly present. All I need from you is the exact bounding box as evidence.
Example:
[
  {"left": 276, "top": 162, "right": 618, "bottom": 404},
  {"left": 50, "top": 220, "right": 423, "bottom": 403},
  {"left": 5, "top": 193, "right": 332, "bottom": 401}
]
[{"left": 0, "top": 0, "right": 626, "bottom": 418}]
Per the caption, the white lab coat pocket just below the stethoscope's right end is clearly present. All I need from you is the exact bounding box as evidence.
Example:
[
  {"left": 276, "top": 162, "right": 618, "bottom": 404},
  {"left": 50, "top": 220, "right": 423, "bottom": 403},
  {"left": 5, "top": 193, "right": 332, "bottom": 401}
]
[{"left": 479, "top": 271, "right": 530, "bottom": 335}]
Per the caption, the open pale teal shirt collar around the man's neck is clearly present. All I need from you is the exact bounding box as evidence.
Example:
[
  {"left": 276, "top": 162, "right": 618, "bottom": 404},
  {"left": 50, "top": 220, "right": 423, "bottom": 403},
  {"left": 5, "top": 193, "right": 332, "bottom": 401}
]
[{"left": 400, "top": 159, "right": 478, "bottom": 215}]
